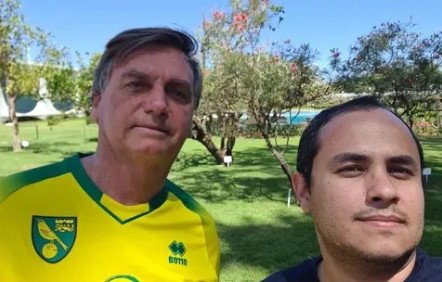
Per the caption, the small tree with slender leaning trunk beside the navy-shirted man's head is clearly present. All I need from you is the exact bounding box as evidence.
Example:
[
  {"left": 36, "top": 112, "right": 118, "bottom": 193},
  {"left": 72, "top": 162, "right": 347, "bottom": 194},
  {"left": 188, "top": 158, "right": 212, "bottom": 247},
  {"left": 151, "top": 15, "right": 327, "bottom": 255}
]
[{"left": 231, "top": 41, "right": 329, "bottom": 183}]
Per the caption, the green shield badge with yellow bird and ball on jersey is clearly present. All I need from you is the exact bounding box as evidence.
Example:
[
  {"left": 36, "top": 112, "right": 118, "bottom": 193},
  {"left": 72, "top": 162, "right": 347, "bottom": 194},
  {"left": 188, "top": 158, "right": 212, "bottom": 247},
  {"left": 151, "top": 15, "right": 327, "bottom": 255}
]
[{"left": 32, "top": 215, "right": 77, "bottom": 263}]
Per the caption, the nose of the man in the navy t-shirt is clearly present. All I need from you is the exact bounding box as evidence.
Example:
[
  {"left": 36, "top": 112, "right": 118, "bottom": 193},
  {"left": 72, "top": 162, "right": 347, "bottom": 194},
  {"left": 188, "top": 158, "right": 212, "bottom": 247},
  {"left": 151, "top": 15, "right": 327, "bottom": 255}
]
[{"left": 366, "top": 168, "right": 399, "bottom": 208}]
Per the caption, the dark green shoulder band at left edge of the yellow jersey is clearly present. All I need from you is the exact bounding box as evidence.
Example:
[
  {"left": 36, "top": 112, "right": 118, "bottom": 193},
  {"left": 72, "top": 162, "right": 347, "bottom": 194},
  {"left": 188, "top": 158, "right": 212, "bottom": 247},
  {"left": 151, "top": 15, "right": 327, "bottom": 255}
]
[{"left": 0, "top": 156, "right": 71, "bottom": 203}]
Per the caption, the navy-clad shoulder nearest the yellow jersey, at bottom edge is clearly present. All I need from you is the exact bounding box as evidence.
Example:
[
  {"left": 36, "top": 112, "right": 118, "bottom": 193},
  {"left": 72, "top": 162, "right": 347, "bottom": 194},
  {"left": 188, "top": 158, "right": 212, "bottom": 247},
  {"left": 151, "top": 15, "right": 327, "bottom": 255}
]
[{"left": 263, "top": 257, "right": 322, "bottom": 282}]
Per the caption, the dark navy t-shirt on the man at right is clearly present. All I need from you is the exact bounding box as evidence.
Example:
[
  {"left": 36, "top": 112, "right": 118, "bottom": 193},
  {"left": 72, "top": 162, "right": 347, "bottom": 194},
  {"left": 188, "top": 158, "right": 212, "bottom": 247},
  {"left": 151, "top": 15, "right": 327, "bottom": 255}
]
[{"left": 263, "top": 248, "right": 442, "bottom": 282}]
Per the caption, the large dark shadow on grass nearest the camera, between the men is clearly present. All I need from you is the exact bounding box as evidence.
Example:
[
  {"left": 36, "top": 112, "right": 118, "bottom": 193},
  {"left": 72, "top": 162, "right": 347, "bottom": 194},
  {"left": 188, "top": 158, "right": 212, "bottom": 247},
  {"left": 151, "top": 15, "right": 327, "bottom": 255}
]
[{"left": 217, "top": 215, "right": 319, "bottom": 279}]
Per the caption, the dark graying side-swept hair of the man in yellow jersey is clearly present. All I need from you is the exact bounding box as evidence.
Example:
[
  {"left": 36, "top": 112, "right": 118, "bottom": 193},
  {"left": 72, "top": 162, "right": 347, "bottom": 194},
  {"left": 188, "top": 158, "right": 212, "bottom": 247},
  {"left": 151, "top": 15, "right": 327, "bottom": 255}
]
[{"left": 91, "top": 27, "right": 202, "bottom": 109}]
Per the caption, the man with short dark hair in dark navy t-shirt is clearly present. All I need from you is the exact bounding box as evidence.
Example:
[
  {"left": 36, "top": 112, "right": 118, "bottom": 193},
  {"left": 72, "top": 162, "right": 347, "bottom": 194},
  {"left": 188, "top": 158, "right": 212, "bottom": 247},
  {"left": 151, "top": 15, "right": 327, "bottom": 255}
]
[{"left": 265, "top": 96, "right": 442, "bottom": 282}]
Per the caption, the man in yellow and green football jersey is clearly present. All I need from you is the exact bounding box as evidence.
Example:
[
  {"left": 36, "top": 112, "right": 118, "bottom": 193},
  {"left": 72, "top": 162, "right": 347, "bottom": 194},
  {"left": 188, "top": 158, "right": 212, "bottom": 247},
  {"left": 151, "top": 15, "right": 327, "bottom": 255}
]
[{"left": 0, "top": 28, "right": 219, "bottom": 281}]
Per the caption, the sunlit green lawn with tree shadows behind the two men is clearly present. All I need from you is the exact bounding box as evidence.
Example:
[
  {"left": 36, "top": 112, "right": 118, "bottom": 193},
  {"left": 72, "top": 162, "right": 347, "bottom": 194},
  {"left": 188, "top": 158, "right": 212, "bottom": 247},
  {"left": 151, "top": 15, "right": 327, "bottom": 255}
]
[{"left": 0, "top": 120, "right": 442, "bottom": 281}]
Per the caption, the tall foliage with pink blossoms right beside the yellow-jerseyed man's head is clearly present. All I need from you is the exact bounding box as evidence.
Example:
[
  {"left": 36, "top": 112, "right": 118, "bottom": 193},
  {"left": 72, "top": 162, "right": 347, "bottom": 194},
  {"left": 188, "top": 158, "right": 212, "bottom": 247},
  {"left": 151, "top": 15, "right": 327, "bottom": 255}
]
[{"left": 198, "top": 0, "right": 283, "bottom": 116}]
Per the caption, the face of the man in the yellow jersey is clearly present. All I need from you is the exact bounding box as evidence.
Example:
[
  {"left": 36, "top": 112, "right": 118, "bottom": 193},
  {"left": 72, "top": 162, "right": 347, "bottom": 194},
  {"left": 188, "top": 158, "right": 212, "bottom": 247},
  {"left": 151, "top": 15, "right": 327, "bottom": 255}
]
[{"left": 92, "top": 46, "right": 194, "bottom": 160}]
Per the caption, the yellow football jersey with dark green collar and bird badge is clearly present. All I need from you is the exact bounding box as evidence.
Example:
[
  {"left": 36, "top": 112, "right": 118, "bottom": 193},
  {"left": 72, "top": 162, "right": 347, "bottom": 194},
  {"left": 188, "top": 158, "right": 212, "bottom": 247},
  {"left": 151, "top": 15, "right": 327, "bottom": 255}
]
[{"left": 0, "top": 155, "right": 220, "bottom": 282}]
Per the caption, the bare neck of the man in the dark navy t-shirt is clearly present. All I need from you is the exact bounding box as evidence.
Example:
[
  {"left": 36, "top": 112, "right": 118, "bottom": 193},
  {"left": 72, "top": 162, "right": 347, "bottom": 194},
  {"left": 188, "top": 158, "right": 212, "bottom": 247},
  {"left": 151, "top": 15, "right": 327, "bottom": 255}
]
[{"left": 318, "top": 248, "right": 416, "bottom": 282}]
